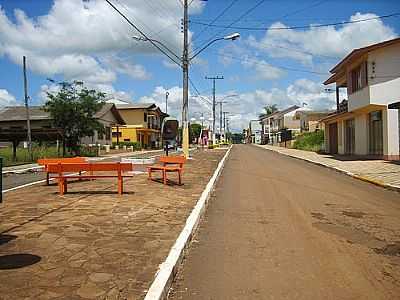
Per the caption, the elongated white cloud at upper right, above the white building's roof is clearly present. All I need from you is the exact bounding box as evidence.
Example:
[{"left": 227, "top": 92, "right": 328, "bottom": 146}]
[{"left": 248, "top": 13, "right": 397, "bottom": 64}]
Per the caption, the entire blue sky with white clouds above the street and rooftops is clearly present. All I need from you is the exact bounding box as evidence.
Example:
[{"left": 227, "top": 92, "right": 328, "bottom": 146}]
[{"left": 0, "top": 0, "right": 400, "bottom": 130}]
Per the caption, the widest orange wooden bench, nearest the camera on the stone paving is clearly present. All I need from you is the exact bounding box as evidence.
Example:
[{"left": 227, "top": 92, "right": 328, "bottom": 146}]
[{"left": 48, "top": 162, "right": 133, "bottom": 195}]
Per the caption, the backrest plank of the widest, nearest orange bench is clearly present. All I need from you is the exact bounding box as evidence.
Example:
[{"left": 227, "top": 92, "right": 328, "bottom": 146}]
[{"left": 48, "top": 162, "right": 133, "bottom": 173}]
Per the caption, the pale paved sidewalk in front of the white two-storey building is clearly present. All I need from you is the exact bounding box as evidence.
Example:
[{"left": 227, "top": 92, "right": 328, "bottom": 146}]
[{"left": 256, "top": 145, "right": 400, "bottom": 191}]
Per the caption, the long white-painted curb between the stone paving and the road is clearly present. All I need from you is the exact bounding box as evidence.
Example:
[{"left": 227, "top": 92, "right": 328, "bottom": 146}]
[{"left": 144, "top": 146, "right": 232, "bottom": 300}]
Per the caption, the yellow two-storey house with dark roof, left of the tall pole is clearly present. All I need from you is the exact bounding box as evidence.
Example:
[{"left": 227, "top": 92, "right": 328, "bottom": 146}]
[{"left": 112, "top": 103, "right": 167, "bottom": 148}]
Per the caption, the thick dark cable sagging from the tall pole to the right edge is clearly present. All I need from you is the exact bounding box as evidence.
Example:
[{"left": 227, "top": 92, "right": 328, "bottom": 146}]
[{"left": 190, "top": 13, "right": 400, "bottom": 31}]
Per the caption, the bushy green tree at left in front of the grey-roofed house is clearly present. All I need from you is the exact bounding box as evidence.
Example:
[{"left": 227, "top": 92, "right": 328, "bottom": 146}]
[{"left": 44, "top": 81, "right": 105, "bottom": 155}]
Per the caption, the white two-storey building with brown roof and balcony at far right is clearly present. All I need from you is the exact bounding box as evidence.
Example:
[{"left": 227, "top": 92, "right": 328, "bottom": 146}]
[{"left": 323, "top": 38, "right": 400, "bottom": 160}]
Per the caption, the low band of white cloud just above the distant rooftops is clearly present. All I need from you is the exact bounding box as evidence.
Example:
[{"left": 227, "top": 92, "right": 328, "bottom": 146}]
[{"left": 134, "top": 78, "right": 338, "bottom": 131}]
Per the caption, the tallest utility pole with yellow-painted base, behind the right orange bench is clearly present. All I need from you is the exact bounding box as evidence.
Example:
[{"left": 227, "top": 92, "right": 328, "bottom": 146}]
[{"left": 182, "top": 0, "right": 189, "bottom": 158}]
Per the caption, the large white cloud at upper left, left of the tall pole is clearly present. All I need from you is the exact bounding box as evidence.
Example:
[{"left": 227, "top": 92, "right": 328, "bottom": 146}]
[{"left": 0, "top": 0, "right": 204, "bottom": 84}]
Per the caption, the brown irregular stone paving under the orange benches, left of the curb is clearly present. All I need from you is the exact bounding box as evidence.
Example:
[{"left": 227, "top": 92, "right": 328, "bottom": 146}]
[{"left": 0, "top": 150, "right": 225, "bottom": 300}]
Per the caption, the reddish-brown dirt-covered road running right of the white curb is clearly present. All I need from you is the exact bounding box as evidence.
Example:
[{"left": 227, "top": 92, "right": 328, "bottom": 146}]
[{"left": 170, "top": 145, "right": 400, "bottom": 300}]
